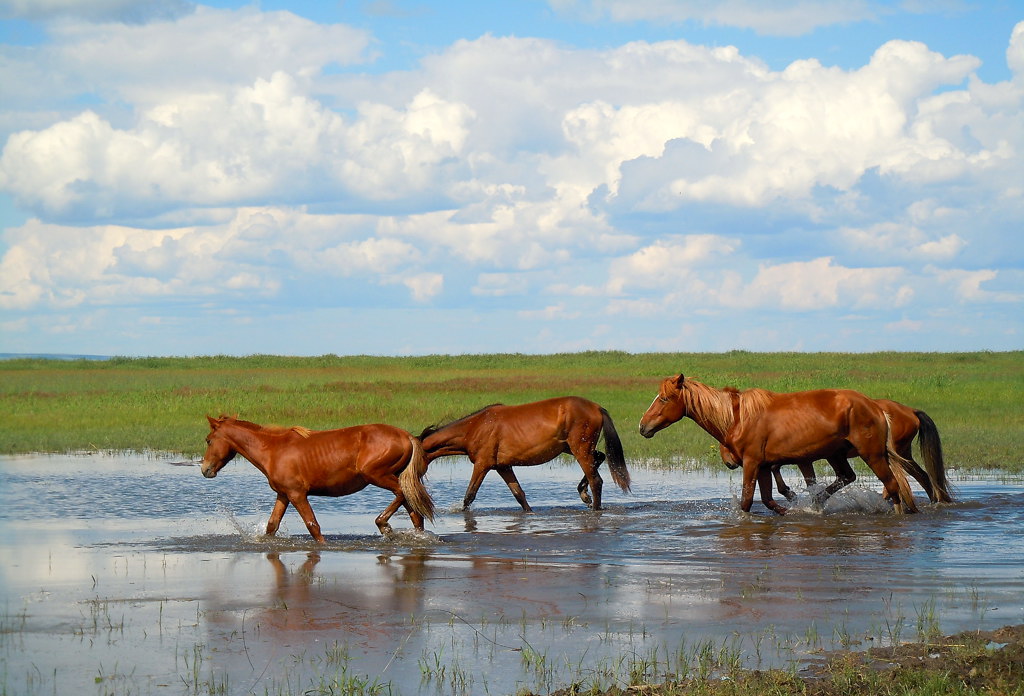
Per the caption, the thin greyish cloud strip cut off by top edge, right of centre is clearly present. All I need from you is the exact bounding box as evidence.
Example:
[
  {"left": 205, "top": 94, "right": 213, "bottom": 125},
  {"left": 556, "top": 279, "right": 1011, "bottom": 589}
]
[{"left": 549, "top": 0, "right": 878, "bottom": 37}]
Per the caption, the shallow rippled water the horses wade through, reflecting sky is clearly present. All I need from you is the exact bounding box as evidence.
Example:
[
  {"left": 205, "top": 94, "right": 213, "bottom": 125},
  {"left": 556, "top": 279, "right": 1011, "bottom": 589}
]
[{"left": 0, "top": 455, "right": 1024, "bottom": 694}]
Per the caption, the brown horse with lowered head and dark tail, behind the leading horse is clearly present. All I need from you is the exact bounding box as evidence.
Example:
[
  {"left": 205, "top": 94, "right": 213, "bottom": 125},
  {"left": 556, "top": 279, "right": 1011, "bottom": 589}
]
[{"left": 420, "top": 396, "right": 630, "bottom": 512}]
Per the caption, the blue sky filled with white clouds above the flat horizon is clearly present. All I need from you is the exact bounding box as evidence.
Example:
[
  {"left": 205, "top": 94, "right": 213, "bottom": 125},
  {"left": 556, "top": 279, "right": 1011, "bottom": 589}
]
[{"left": 0, "top": 0, "right": 1024, "bottom": 355}]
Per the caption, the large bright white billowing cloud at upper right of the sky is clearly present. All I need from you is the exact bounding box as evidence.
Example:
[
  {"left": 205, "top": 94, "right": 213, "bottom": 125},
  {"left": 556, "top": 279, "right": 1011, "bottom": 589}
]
[{"left": 591, "top": 41, "right": 983, "bottom": 211}]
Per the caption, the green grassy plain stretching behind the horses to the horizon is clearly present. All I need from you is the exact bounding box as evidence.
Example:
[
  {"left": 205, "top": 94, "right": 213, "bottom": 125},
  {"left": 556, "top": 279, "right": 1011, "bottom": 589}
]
[{"left": 0, "top": 351, "right": 1024, "bottom": 472}]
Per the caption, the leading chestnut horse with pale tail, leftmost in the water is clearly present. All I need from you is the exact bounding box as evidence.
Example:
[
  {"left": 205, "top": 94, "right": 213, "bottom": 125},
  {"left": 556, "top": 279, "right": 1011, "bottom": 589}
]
[{"left": 203, "top": 416, "right": 433, "bottom": 543}]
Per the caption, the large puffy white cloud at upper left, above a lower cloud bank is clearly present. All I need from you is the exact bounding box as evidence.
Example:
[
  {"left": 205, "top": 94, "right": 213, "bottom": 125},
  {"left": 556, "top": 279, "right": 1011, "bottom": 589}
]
[{"left": 0, "top": 73, "right": 472, "bottom": 220}]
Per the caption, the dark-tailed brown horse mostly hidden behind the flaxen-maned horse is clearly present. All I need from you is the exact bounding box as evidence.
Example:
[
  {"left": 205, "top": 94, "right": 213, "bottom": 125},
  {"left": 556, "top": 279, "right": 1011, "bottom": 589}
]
[{"left": 772, "top": 399, "right": 953, "bottom": 503}]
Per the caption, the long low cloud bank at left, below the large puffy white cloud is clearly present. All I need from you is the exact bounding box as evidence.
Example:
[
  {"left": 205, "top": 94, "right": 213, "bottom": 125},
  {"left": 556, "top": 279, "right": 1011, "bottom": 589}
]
[{"left": 0, "top": 208, "right": 443, "bottom": 310}]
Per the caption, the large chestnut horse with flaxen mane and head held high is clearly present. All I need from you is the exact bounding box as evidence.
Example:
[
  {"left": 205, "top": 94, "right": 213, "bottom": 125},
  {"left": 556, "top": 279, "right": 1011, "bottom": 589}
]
[{"left": 640, "top": 375, "right": 916, "bottom": 515}]
